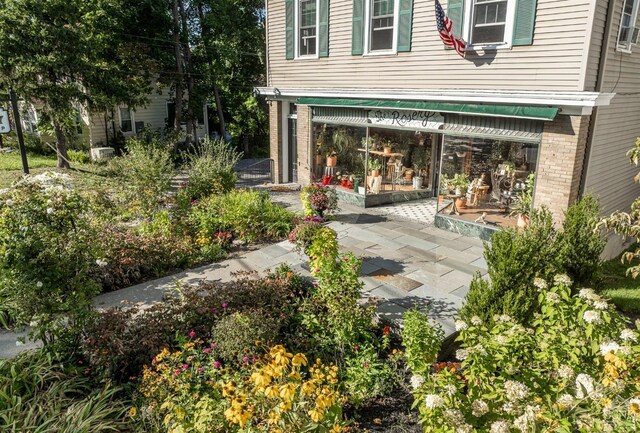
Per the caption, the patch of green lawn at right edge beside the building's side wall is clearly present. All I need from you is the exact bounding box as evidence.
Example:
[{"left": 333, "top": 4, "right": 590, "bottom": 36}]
[{"left": 600, "top": 246, "right": 640, "bottom": 314}]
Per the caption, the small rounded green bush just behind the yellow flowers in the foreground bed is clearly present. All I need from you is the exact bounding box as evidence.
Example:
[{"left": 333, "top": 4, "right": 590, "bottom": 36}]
[{"left": 211, "top": 310, "right": 279, "bottom": 367}]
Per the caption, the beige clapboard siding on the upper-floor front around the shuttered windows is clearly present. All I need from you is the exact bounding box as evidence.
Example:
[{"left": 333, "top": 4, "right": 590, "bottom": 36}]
[{"left": 267, "top": 0, "right": 595, "bottom": 90}]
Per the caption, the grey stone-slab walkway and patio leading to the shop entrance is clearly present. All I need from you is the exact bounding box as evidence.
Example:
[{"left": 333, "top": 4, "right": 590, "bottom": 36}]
[{"left": 0, "top": 193, "right": 486, "bottom": 358}]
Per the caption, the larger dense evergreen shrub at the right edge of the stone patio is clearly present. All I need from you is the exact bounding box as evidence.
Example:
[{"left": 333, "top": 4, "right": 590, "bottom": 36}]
[{"left": 460, "top": 208, "right": 560, "bottom": 323}]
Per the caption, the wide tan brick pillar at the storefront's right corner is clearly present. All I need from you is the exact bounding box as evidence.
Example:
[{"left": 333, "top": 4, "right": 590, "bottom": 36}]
[{"left": 534, "top": 115, "right": 590, "bottom": 224}]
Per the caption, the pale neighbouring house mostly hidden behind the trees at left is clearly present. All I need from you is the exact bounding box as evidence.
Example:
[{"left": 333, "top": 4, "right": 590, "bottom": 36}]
[{"left": 22, "top": 85, "right": 210, "bottom": 148}]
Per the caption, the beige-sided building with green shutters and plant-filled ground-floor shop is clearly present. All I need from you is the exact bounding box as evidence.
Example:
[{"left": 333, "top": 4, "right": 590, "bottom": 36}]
[{"left": 257, "top": 0, "right": 640, "bottom": 252}]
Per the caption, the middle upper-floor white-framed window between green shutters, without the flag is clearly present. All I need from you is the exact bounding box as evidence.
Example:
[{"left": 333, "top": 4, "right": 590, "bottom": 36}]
[{"left": 365, "top": 0, "right": 400, "bottom": 54}]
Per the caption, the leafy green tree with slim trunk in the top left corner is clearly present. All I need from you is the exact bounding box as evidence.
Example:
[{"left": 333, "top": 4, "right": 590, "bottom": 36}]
[{"left": 0, "top": 0, "right": 159, "bottom": 168}]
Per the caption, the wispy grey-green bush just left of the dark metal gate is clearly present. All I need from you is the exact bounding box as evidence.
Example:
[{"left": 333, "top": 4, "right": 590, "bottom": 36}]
[{"left": 184, "top": 139, "right": 242, "bottom": 200}]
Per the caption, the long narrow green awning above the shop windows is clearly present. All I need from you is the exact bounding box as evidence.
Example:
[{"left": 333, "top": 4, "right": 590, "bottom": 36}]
[{"left": 298, "top": 98, "right": 558, "bottom": 120}]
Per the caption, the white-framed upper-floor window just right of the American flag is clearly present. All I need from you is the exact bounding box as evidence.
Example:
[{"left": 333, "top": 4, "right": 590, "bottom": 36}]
[{"left": 463, "top": 0, "right": 516, "bottom": 48}]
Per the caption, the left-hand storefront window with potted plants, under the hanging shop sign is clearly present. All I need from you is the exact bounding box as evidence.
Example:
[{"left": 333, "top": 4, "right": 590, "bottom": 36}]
[{"left": 314, "top": 123, "right": 434, "bottom": 194}]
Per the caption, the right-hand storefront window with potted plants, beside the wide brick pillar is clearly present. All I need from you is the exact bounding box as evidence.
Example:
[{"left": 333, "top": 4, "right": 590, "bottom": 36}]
[{"left": 438, "top": 136, "right": 538, "bottom": 227}]
